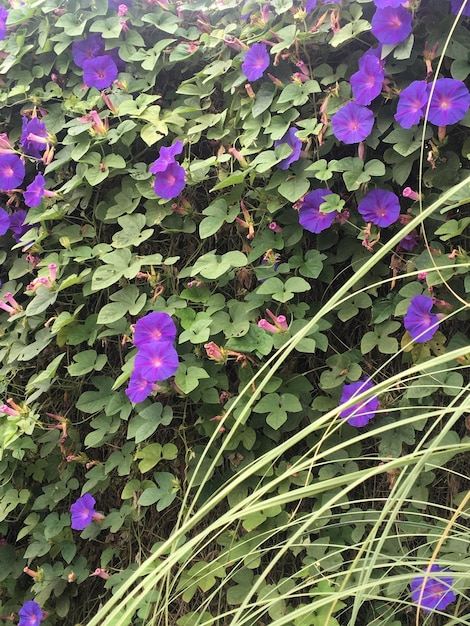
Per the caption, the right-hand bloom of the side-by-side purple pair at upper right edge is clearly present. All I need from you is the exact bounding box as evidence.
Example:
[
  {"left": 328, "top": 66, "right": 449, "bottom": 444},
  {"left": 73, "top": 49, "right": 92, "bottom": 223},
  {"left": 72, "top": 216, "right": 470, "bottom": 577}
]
[{"left": 428, "top": 78, "right": 470, "bottom": 126}]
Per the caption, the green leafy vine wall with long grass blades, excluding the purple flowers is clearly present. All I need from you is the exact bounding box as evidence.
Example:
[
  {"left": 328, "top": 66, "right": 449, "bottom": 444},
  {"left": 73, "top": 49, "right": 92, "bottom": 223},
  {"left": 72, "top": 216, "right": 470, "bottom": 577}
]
[{"left": 0, "top": 0, "right": 470, "bottom": 626}]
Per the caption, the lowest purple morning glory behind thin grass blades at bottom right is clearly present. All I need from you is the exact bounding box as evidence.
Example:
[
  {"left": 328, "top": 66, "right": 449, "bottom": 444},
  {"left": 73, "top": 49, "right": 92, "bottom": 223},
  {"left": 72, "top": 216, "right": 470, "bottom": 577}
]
[{"left": 410, "top": 564, "right": 456, "bottom": 613}]
